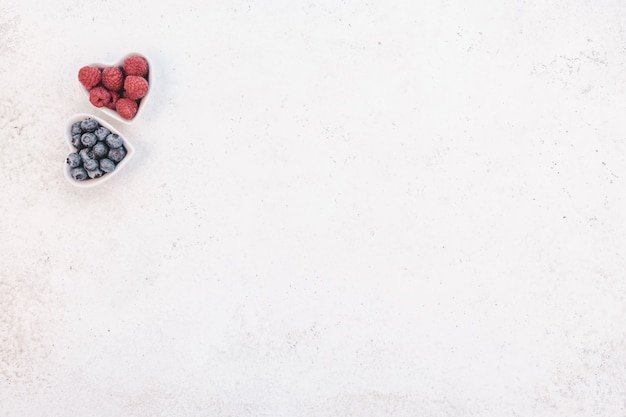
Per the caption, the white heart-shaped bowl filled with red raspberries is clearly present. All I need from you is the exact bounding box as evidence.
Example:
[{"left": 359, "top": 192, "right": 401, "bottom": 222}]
[{"left": 78, "top": 53, "right": 152, "bottom": 124}]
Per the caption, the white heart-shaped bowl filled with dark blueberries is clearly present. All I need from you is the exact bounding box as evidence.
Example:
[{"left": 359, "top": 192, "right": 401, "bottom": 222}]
[{"left": 64, "top": 113, "right": 135, "bottom": 188}]
